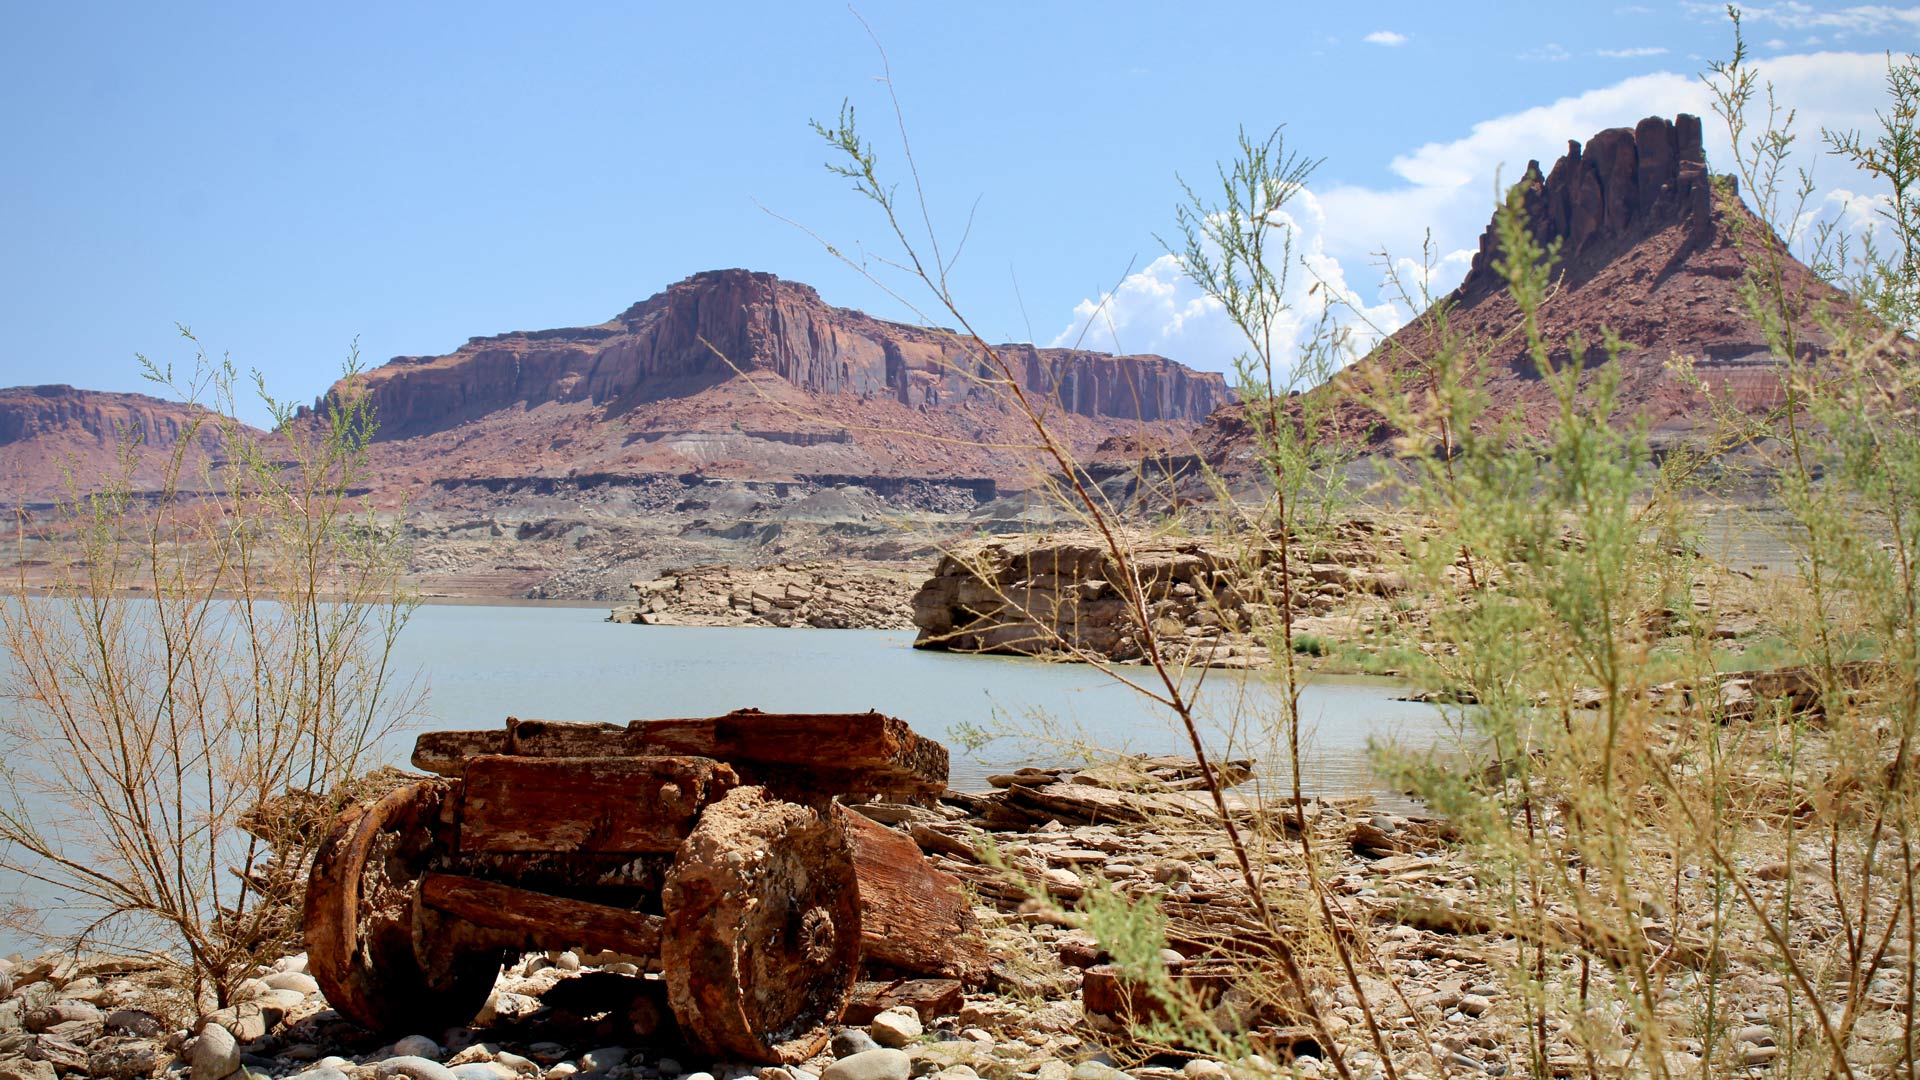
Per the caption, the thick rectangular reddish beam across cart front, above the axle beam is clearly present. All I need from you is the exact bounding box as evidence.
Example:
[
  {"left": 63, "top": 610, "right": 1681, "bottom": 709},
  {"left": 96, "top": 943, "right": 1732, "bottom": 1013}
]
[{"left": 459, "top": 755, "right": 739, "bottom": 853}]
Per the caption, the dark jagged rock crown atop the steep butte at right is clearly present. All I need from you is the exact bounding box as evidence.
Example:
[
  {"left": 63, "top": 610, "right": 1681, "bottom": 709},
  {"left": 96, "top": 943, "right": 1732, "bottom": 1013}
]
[{"left": 1455, "top": 113, "right": 1713, "bottom": 304}]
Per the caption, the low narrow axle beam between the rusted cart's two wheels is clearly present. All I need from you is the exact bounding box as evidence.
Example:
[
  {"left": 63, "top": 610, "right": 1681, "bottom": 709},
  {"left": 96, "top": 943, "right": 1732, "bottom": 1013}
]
[{"left": 420, "top": 874, "right": 662, "bottom": 957}]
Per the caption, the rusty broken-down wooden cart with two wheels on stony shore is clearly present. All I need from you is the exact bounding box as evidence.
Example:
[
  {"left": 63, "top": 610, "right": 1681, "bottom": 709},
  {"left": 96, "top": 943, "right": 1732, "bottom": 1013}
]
[{"left": 305, "top": 709, "right": 981, "bottom": 1063}]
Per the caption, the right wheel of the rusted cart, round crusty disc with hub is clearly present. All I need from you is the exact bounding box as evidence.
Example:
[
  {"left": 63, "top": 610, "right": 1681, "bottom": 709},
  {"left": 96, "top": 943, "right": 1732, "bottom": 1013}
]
[{"left": 660, "top": 788, "right": 860, "bottom": 1065}]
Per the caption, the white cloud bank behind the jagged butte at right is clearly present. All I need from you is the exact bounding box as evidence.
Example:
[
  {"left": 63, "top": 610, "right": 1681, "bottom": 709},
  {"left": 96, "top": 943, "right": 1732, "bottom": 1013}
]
[{"left": 1054, "top": 52, "right": 1885, "bottom": 386}]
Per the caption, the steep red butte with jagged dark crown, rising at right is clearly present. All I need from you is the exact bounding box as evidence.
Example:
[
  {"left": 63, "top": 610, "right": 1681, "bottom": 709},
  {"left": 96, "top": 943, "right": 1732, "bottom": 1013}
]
[{"left": 1194, "top": 115, "right": 1847, "bottom": 475}]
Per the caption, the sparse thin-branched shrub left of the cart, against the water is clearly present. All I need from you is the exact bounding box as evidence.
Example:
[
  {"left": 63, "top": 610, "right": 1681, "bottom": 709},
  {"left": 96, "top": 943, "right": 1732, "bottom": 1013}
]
[{"left": 0, "top": 331, "right": 417, "bottom": 1005}]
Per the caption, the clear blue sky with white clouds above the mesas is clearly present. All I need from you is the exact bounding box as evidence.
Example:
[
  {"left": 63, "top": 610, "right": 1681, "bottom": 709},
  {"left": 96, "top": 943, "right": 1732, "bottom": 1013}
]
[{"left": 0, "top": 2, "right": 1920, "bottom": 419}]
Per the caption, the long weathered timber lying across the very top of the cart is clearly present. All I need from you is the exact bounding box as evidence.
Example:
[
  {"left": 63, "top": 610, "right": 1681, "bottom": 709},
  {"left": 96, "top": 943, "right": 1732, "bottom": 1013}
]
[{"left": 413, "top": 709, "right": 947, "bottom": 798}]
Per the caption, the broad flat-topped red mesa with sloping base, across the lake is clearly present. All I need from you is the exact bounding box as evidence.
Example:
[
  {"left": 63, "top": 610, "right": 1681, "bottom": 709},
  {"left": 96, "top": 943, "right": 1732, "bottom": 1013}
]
[{"left": 316, "top": 269, "right": 1229, "bottom": 484}]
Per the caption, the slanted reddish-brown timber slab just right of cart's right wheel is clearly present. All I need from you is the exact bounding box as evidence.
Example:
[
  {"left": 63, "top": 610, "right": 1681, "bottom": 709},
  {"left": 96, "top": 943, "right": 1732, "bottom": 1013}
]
[{"left": 839, "top": 807, "right": 987, "bottom": 984}]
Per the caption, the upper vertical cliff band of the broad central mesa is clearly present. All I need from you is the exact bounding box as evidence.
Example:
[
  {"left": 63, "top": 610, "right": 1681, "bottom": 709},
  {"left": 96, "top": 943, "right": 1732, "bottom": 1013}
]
[{"left": 341, "top": 269, "right": 1229, "bottom": 440}]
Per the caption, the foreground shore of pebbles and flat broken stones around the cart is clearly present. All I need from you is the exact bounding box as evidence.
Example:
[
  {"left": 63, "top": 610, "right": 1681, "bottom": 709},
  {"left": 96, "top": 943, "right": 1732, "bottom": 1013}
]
[{"left": 0, "top": 759, "right": 1822, "bottom": 1080}]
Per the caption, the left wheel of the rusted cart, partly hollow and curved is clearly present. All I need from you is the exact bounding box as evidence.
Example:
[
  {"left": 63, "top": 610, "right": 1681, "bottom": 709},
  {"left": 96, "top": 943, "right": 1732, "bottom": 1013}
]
[{"left": 305, "top": 780, "right": 499, "bottom": 1034}]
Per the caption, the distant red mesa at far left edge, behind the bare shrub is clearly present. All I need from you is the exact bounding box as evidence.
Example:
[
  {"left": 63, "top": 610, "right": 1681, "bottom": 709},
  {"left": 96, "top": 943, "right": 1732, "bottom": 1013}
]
[{"left": 0, "top": 386, "right": 247, "bottom": 505}]
